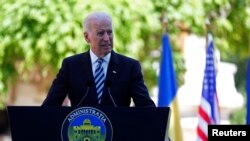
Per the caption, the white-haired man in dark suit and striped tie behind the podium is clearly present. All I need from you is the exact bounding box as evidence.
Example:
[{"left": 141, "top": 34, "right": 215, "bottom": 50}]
[{"left": 42, "top": 12, "right": 155, "bottom": 107}]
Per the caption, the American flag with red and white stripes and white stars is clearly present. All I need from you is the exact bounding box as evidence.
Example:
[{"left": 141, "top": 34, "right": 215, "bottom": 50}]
[{"left": 197, "top": 33, "right": 220, "bottom": 141}]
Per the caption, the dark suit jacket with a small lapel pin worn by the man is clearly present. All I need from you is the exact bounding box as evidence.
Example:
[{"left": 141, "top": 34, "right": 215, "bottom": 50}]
[{"left": 42, "top": 51, "right": 155, "bottom": 107}]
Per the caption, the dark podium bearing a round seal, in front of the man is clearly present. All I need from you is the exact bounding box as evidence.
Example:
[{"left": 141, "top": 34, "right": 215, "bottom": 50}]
[{"left": 7, "top": 106, "right": 170, "bottom": 141}]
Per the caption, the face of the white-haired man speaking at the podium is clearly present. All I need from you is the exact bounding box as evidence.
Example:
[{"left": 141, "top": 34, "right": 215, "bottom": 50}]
[{"left": 84, "top": 19, "right": 113, "bottom": 57}]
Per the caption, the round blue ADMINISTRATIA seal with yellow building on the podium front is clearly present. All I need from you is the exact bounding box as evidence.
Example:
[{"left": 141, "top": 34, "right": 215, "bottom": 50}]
[{"left": 61, "top": 107, "right": 113, "bottom": 141}]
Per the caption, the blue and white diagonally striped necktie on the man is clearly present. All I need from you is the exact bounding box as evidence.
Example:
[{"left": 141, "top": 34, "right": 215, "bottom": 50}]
[{"left": 95, "top": 58, "right": 105, "bottom": 104}]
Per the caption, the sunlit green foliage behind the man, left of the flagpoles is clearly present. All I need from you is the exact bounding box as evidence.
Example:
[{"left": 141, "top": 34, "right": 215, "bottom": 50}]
[{"left": 0, "top": 0, "right": 165, "bottom": 94}]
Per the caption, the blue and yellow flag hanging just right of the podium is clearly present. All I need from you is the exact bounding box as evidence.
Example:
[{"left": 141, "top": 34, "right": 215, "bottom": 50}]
[{"left": 158, "top": 33, "right": 182, "bottom": 141}]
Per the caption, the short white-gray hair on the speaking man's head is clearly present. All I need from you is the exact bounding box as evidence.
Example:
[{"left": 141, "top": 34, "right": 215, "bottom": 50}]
[{"left": 83, "top": 12, "right": 112, "bottom": 32}]
